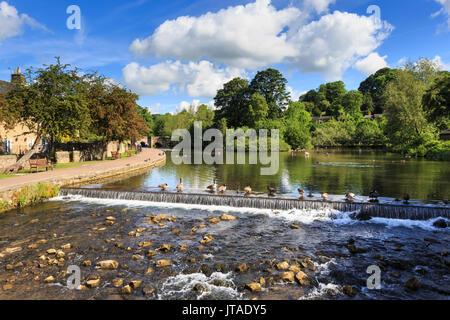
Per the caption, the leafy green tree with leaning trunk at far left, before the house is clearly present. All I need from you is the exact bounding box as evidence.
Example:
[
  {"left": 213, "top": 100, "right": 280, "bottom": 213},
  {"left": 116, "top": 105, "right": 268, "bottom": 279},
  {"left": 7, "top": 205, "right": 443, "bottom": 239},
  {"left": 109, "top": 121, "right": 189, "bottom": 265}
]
[{"left": 0, "top": 58, "right": 90, "bottom": 173}]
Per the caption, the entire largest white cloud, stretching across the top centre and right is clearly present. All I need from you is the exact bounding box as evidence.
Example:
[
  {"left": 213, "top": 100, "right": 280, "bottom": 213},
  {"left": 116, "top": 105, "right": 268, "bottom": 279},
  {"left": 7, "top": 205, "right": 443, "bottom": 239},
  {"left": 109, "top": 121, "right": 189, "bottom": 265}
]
[{"left": 130, "top": 0, "right": 393, "bottom": 80}]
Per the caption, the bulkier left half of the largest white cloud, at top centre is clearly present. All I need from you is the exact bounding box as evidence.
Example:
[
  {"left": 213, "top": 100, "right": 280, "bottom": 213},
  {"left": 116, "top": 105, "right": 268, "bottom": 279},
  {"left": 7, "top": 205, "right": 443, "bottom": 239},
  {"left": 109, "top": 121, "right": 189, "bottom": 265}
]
[{"left": 130, "top": 0, "right": 301, "bottom": 69}]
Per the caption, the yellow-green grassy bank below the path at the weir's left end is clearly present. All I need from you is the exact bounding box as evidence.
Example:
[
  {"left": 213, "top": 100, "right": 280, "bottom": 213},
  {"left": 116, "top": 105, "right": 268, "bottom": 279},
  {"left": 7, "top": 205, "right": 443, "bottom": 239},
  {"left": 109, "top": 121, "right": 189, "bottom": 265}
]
[{"left": 0, "top": 183, "right": 59, "bottom": 212}]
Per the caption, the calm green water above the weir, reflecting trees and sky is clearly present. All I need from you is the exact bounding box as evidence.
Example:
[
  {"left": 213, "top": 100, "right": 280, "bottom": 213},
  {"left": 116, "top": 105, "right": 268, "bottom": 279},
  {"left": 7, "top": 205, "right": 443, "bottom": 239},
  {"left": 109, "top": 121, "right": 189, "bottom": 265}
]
[{"left": 103, "top": 150, "right": 450, "bottom": 201}]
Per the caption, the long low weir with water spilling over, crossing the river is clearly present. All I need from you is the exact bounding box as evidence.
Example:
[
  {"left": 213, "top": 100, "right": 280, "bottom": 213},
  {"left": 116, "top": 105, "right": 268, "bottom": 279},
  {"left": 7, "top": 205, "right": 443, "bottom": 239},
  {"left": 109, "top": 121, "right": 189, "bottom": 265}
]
[{"left": 59, "top": 188, "right": 450, "bottom": 220}]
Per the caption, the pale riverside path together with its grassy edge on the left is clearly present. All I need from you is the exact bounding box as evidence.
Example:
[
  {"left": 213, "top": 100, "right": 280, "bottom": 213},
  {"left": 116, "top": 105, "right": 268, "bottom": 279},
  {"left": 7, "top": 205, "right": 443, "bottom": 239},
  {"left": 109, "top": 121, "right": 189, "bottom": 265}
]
[{"left": 0, "top": 149, "right": 166, "bottom": 212}]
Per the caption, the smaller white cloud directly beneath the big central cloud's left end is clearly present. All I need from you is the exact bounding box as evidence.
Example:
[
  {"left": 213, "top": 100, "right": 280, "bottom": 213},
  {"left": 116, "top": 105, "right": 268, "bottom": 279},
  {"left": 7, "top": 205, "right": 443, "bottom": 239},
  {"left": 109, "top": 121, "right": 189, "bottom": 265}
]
[{"left": 123, "top": 60, "right": 244, "bottom": 98}]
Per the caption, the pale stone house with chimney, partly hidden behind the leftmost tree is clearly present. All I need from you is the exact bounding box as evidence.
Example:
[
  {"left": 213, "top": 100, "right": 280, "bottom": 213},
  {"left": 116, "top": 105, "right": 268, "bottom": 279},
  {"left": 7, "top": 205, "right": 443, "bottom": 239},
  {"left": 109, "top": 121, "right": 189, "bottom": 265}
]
[{"left": 0, "top": 68, "right": 36, "bottom": 155}]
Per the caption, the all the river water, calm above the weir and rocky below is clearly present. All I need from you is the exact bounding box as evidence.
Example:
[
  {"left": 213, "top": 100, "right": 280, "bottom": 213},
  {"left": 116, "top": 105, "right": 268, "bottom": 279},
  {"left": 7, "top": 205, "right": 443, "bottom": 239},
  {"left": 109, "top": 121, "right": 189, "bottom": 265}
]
[{"left": 0, "top": 152, "right": 450, "bottom": 299}]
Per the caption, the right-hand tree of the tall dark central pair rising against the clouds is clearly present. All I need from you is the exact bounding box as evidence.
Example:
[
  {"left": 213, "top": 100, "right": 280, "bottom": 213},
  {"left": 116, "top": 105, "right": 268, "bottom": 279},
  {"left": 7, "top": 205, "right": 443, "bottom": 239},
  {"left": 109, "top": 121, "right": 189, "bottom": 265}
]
[{"left": 249, "top": 68, "right": 291, "bottom": 119}]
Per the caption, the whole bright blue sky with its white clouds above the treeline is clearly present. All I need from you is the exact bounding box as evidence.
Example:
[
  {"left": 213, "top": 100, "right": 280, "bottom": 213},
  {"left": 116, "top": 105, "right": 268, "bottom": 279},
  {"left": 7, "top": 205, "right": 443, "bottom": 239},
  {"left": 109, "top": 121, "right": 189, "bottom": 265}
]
[{"left": 0, "top": 0, "right": 450, "bottom": 113}]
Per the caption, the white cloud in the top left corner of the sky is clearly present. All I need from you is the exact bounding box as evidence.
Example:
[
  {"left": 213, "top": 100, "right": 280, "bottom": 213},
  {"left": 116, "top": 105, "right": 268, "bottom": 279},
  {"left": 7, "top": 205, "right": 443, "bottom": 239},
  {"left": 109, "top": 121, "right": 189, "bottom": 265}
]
[{"left": 0, "top": 1, "right": 46, "bottom": 43}]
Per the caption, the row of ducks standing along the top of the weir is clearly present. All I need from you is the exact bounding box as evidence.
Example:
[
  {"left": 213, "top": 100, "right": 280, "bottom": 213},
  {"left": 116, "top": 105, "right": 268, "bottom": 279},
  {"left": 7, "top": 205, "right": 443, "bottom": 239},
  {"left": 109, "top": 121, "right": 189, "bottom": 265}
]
[{"left": 158, "top": 179, "right": 428, "bottom": 204}]
